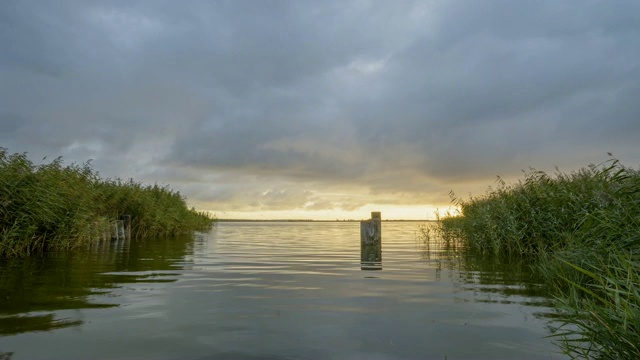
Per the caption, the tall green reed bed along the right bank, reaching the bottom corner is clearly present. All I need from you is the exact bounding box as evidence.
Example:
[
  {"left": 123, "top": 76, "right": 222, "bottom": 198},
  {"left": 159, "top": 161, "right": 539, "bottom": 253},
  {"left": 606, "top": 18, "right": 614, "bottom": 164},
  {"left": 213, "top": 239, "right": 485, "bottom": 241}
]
[{"left": 425, "top": 159, "right": 640, "bottom": 359}]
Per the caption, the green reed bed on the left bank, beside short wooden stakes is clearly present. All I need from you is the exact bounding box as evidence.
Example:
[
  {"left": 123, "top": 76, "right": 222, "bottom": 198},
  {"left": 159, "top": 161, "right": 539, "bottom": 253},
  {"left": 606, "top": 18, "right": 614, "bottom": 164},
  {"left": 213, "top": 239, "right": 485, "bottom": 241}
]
[{"left": 0, "top": 148, "right": 214, "bottom": 257}]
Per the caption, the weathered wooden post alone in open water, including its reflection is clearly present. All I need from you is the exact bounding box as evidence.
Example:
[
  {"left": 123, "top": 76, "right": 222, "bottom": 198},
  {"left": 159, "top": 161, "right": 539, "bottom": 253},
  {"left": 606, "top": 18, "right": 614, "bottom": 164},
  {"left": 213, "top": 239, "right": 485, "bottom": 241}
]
[{"left": 360, "top": 211, "right": 382, "bottom": 270}]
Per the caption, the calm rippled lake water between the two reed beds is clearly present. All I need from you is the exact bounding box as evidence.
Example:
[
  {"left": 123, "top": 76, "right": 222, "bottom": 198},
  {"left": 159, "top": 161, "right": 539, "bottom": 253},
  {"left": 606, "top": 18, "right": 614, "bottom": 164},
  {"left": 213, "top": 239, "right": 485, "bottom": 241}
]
[{"left": 0, "top": 222, "right": 563, "bottom": 360}]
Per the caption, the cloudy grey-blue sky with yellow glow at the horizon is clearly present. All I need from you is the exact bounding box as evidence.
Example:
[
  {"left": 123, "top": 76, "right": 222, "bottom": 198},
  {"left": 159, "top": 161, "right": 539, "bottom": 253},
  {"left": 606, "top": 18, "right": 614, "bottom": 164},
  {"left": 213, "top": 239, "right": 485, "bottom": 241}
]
[{"left": 0, "top": 0, "right": 640, "bottom": 219}]
